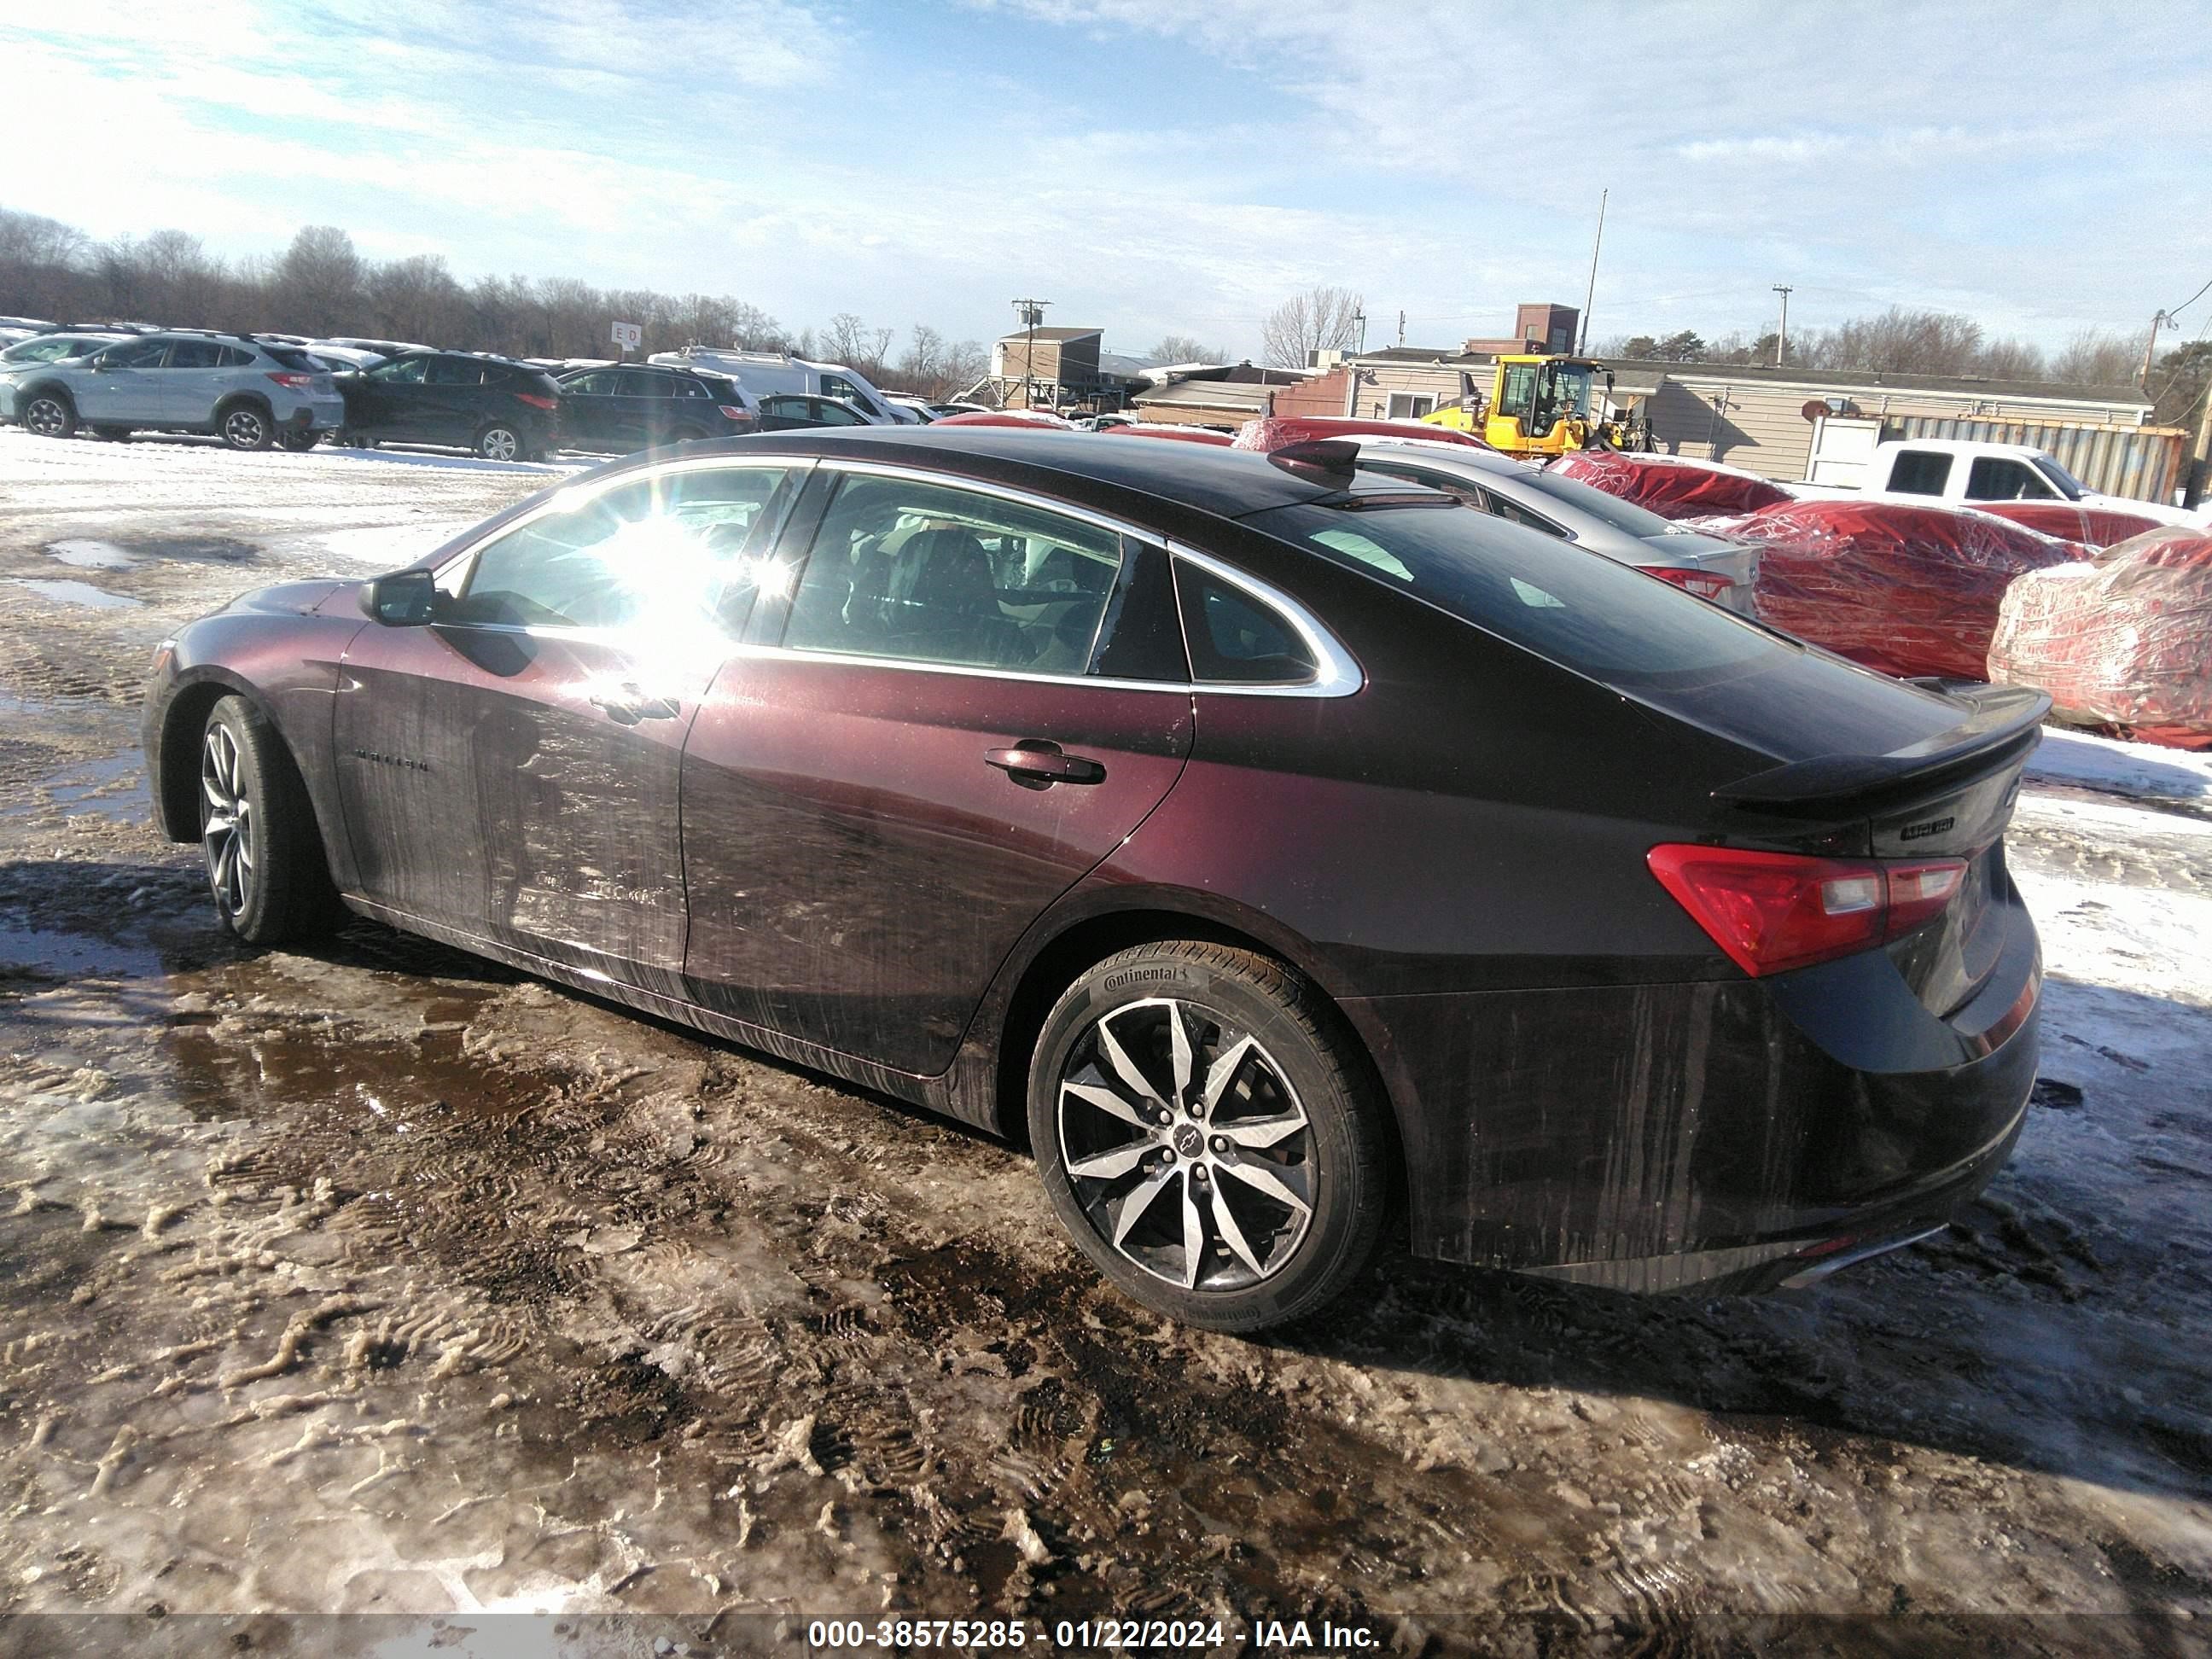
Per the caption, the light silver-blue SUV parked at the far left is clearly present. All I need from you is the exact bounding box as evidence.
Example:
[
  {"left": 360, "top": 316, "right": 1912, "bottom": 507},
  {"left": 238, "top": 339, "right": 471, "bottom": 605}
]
[{"left": 0, "top": 329, "right": 345, "bottom": 449}]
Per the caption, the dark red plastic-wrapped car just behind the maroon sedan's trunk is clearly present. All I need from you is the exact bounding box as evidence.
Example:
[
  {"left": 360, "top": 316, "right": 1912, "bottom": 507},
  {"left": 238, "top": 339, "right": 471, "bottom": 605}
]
[{"left": 1727, "top": 502, "right": 2079, "bottom": 679}]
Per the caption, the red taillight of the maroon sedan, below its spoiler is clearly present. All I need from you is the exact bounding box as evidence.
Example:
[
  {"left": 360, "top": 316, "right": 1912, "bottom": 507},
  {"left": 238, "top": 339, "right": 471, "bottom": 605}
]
[{"left": 1645, "top": 843, "right": 1966, "bottom": 978}]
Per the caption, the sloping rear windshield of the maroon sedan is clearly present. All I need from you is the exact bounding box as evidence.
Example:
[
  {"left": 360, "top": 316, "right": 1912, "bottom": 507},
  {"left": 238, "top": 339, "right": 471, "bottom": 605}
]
[{"left": 1245, "top": 504, "right": 1798, "bottom": 688}]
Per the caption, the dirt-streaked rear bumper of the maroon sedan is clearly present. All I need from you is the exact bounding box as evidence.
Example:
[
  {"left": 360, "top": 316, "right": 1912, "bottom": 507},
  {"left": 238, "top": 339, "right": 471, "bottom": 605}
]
[{"left": 1348, "top": 905, "right": 2041, "bottom": 1292}]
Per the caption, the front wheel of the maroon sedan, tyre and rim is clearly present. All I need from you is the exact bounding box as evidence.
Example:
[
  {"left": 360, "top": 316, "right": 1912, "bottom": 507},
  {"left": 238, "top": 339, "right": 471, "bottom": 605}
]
[{"left": 199, "top": 696, "right": 339, "bottom": 945}]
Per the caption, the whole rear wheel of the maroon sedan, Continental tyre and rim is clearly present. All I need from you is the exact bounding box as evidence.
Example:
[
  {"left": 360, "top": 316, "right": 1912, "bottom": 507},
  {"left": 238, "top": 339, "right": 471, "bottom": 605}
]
[{"left": 1028, "top": 940, "right": 1389, "bottom": 1331}]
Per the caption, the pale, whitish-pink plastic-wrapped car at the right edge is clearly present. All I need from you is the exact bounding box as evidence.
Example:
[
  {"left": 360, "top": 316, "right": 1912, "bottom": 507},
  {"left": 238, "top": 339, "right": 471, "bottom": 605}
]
[{"left": 1988, "top": 527, "right": 2212, "bottom": 750}]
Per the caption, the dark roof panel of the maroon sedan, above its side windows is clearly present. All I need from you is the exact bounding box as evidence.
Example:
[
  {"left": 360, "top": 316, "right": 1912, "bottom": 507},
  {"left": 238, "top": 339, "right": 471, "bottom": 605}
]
[{"left": 619, "top": 424, "right": 1451, "bottom": 518}]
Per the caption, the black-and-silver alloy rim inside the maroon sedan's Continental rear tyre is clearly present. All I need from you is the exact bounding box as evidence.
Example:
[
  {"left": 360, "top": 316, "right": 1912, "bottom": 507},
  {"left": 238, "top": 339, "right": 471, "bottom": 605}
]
[{"left": 1057, "top": 998, "right": 1318, "bottom": 1289}]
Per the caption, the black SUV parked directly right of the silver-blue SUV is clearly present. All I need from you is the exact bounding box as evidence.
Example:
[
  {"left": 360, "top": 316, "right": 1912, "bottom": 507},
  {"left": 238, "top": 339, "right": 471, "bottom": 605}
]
[{"left": 332, "top": 352, "right": 560, "bottom": 460}]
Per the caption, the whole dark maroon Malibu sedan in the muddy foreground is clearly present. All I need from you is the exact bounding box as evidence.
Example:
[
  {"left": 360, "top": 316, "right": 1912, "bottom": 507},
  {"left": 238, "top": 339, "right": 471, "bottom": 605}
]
[{"left": 133, "top": 427, "right": 2044, "bottom": 1330}]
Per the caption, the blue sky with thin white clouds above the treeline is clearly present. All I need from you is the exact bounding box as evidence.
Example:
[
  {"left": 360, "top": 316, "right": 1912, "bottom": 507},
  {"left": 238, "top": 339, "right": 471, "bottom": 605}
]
[{"left": 0, "top": 0, "right": 2212, "bottom": 363}]
